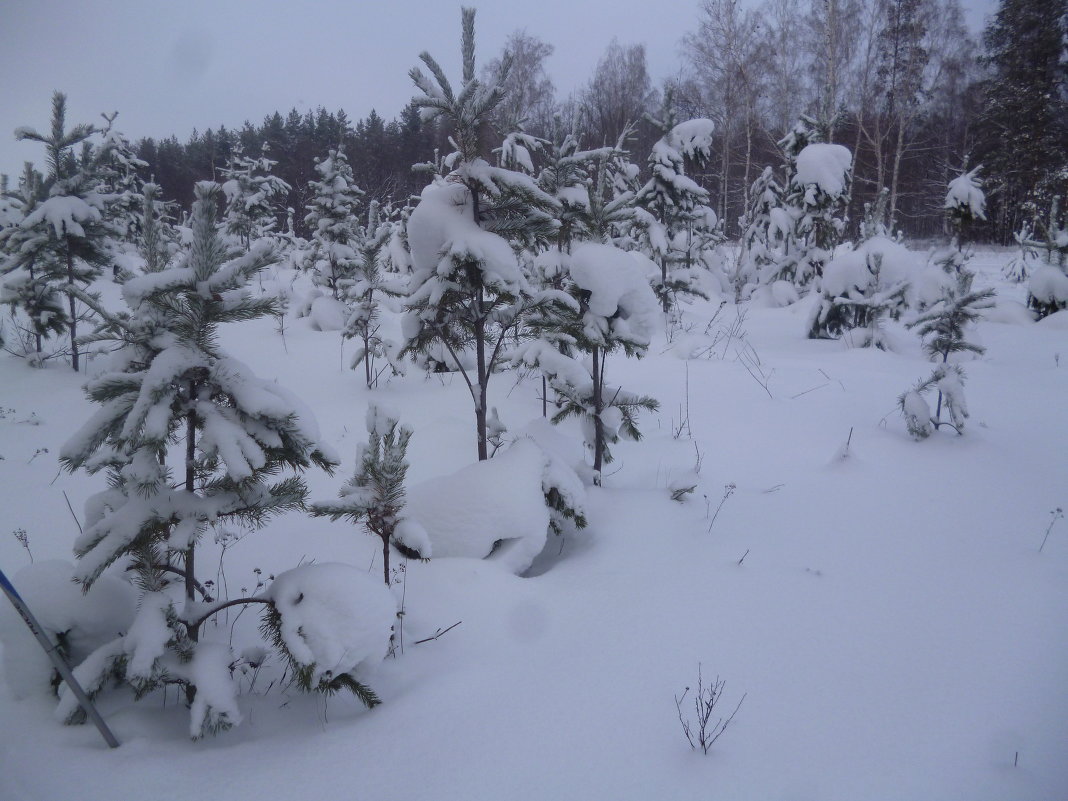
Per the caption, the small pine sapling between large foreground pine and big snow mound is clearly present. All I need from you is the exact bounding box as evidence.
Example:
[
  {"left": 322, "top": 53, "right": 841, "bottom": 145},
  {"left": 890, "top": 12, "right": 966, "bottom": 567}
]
[{"left": 310, "top": 406, "right": 430, "bottom": 586}]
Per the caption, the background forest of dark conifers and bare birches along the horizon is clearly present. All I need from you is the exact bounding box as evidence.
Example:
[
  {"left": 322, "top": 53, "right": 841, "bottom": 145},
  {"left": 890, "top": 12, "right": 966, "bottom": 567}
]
[{"left": 112, "top": 0, "right": 1068, "bottom": 242}]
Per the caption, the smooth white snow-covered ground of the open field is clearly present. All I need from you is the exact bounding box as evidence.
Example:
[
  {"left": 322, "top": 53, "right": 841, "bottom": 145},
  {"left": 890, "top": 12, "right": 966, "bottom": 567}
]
[{"left": 0, "top": 251, "right": 1068, "bottom": 801}]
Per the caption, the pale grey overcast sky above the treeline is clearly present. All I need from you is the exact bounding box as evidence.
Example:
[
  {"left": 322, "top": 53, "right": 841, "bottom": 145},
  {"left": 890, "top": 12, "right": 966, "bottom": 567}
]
[{"left": 0, "top": 0, "right": 995, "bottom": 180}]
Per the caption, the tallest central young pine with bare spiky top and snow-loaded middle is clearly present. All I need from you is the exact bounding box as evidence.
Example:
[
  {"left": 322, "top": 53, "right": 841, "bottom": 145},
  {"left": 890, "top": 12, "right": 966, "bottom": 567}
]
[{"left": 405, "top": 9, "right": 556, "bottom": 460}]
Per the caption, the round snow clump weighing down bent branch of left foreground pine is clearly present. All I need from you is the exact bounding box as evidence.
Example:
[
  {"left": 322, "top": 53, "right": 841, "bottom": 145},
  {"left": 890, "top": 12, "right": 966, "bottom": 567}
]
[{"left": 265, "top": 563, "right": 397, "bottom": 687}]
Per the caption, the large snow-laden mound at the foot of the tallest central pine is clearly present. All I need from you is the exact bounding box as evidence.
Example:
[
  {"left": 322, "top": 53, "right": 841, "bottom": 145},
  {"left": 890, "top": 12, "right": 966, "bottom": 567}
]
[{"left": 407, "top": 437, "right": 585, "bottom": 574}]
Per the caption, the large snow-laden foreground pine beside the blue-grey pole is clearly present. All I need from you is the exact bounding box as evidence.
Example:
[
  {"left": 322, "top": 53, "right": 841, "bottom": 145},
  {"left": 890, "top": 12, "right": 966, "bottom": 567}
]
[{"left": 60, "top": 182, "right": 336, "bottom": 737}]
